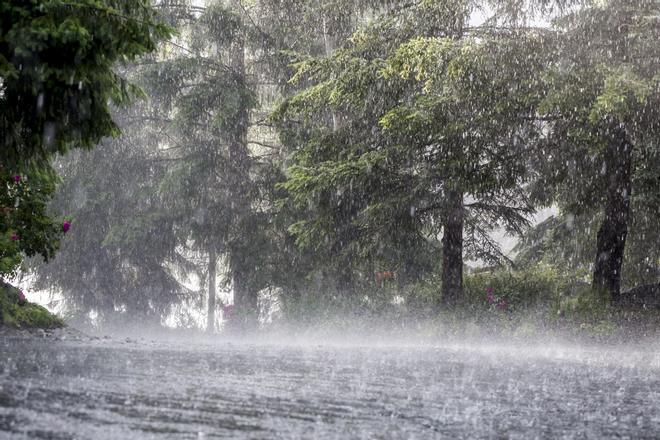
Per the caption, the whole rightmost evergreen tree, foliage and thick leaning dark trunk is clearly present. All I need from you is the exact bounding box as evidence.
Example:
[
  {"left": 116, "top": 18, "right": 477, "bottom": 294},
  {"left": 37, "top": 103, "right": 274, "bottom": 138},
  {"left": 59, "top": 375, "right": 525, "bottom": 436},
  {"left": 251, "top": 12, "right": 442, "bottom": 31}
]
[{"left": 535, "top": 0, "right": 660, "bottom": 301}]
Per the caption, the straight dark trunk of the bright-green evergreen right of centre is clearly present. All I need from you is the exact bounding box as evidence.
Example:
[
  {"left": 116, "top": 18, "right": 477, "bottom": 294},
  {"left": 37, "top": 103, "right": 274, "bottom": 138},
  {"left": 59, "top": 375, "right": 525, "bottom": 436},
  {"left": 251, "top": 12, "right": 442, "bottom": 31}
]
[{"left": 442, "top": 190, "right": 464, "bottom": 307}]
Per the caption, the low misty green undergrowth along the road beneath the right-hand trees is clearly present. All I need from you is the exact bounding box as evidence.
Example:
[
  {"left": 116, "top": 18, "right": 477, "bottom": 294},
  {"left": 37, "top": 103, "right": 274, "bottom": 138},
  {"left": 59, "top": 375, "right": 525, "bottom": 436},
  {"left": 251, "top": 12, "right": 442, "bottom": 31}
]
[{"left": 281, "top": 264, "right": 660, "bottom": 340}]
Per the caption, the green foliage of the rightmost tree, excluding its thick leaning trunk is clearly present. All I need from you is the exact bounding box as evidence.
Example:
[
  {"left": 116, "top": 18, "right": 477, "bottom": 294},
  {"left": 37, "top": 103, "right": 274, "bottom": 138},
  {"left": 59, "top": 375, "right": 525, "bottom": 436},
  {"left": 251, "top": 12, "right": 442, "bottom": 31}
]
[{"left": 532, "top": 0, "right": 660, "bottom": 217}]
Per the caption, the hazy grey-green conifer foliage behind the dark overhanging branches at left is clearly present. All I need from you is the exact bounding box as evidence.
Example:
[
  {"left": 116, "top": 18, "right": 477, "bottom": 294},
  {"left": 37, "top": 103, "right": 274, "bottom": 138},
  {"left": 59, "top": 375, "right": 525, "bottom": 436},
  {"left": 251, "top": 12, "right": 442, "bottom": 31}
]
[{"left": 32, "top": 2, "right": 330, "bottom": 322}]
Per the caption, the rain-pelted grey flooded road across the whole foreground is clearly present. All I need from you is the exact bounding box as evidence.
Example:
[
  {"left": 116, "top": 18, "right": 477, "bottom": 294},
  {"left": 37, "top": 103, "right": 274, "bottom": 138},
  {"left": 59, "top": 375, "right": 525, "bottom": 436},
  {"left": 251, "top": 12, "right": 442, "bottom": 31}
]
[{"left": 0, "top": 338, "right": 660, "bottom": 440}]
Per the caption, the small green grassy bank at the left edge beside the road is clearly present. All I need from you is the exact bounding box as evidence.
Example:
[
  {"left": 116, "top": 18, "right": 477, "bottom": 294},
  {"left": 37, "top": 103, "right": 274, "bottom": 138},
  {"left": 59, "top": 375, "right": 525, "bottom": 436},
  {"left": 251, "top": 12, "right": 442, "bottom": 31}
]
[{"left": 0, "top": 281, "right": 65, "bottom": 329}]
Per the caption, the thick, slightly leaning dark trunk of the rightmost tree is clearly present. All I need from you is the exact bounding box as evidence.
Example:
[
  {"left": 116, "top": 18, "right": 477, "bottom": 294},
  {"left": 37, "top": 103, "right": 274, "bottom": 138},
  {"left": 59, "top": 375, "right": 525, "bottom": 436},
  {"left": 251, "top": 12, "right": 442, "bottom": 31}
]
[{"left": 592, "top": 128, "right": 633, "bottom": 302}]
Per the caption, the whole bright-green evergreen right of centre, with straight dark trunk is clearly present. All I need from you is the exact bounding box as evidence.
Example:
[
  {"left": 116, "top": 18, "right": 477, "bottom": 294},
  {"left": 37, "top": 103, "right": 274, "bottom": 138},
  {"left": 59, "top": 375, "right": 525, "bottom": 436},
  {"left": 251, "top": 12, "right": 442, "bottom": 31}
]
[{"left": 275, "top": 2, "right": 543, "bottom": 304}]
